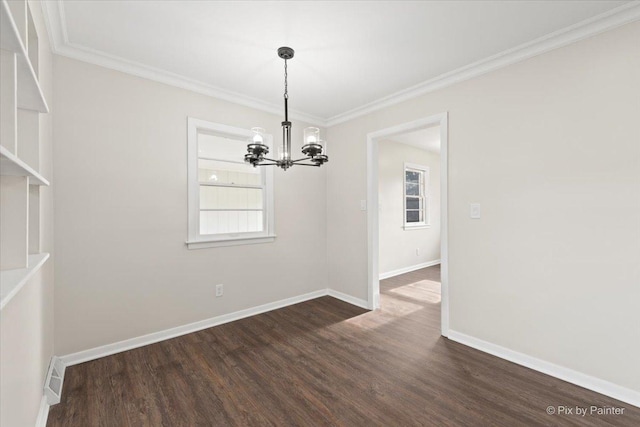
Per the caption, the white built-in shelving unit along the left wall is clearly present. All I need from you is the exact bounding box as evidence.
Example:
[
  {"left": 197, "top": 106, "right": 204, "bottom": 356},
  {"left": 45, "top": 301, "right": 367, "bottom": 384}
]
[{"left": 0, "top": 0, "right": 49, "bottom": 309}]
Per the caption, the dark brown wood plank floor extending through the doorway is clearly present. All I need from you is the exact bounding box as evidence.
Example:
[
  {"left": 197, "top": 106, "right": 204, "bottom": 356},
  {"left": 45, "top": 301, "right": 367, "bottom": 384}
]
[{"left": 47, "top": 266, "right": 640, "bottom": 427}]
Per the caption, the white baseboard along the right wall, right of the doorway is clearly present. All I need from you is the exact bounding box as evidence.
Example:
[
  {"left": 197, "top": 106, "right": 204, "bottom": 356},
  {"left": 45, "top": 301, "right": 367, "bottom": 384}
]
[{"left": 448, "top": 330, "right": 640, "bottom": 407}]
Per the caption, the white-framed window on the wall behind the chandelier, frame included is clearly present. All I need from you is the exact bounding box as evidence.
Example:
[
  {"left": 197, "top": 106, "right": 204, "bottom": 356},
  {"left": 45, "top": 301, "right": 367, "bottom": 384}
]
[{"left": 187, "top": 118, "right": 275, "bottom": 249}]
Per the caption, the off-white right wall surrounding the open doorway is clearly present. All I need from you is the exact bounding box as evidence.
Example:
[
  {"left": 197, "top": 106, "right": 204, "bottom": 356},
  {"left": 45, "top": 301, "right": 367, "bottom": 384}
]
[{"left": 327, "top": 23, "right": 640, "bottom": 391}]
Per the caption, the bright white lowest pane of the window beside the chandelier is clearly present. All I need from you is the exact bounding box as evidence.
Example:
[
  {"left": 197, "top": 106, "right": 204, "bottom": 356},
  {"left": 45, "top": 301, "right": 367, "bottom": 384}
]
[{"left": 200, "top": 211, "right": 264, "bottom": 234}]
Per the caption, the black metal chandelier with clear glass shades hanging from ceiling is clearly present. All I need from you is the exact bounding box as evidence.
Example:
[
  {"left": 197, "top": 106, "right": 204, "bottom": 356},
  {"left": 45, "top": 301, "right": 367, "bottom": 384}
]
[{"left": 244, "top": 47, "right": 329, "bottom": 170}]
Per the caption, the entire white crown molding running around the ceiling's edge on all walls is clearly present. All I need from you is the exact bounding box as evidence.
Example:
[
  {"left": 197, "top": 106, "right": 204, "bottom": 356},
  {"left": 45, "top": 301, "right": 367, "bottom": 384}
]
[{"left": 41, "top": 0, "right": 640, "bottom": 127}]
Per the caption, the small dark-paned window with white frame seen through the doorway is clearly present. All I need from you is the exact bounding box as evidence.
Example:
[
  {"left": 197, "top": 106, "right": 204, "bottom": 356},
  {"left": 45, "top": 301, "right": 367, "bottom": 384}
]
[{"left": 404, "top": 163, "right": 429, "bottom": 229}]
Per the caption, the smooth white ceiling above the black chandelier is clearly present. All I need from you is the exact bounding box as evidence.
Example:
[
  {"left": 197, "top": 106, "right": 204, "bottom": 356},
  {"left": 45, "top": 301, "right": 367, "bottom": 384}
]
[{"left": 43, "top": 0, "right": 632, "bottom": 125}]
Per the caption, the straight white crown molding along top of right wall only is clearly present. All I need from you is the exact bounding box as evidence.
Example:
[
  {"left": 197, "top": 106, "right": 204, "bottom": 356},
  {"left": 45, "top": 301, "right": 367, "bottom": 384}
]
[{"left": 326, "top": 1, "right": 640, "bottom": 127}]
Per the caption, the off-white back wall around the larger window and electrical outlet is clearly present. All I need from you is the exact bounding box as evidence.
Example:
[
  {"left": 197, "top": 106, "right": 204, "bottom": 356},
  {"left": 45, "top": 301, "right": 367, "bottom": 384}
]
[{"left": 54, "top": 57, "right": 327, "bottom": 355}]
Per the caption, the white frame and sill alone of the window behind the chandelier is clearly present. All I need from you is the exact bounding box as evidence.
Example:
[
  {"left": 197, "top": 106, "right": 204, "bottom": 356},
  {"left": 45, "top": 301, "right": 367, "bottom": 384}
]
[{"left": 186, "top": 117, "right": 276, "bottom": 249}]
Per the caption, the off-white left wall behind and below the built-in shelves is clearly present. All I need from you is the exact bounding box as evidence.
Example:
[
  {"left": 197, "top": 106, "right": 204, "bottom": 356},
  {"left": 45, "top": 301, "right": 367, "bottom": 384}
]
[{"left": 0, "top": 1, "right": 56, "bottom": 427}]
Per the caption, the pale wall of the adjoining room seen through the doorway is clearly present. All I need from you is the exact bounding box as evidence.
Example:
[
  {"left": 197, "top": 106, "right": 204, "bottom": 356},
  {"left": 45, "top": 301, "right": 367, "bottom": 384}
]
[{"left": 378, "top": 140, "right": 440, "bottom": 276}]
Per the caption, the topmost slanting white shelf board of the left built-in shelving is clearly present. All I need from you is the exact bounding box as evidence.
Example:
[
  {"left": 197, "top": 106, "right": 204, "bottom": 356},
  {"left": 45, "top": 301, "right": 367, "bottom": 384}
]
[{"left": 0, "top": 0, "right": 49, "bottom": 113}]
